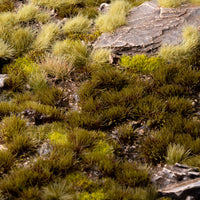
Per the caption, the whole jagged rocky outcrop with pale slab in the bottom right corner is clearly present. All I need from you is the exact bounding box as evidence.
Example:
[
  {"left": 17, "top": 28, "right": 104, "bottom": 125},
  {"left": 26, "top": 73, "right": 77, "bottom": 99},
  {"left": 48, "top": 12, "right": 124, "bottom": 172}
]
[{"left": 152, "top": 163, "right": 200, "bottom": 200}]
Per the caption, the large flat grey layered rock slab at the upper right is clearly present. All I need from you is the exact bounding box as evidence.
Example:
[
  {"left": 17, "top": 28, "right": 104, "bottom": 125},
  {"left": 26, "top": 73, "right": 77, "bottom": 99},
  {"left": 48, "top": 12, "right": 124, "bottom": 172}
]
[{"left": 94, "top": 0, "right": 200, "bottom": 54}]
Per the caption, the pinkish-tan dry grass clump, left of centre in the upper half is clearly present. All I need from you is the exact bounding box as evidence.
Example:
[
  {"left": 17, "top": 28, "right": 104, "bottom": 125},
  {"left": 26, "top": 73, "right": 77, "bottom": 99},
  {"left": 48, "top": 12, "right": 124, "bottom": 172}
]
[{"left": 40, "top": 54, "right": 73, "bottom": 80}]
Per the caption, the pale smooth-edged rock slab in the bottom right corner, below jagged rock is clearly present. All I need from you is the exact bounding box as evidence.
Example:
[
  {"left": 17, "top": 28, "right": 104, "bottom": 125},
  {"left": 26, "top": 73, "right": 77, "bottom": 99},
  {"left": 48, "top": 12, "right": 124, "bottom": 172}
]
[{"left": 159, "top": 178, "right": 200, "bottom": 200}]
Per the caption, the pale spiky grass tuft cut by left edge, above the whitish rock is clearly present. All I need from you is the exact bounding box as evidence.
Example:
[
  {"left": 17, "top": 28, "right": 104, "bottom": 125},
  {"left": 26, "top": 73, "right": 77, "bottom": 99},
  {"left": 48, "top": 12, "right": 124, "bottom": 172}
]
[{"left": 0, "top": 39, "right": 15, "bottom": 60}]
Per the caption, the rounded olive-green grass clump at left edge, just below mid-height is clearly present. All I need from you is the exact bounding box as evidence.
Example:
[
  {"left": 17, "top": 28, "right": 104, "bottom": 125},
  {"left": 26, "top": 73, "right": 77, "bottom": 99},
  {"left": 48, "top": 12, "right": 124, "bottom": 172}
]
[{"left": 1, "top": 115, "right": 27, "bottom": 142}]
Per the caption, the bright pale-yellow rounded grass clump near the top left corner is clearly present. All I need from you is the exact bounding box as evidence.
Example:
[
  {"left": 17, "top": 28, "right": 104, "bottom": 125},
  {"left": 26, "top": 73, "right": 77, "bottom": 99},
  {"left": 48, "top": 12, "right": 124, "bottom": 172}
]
[{"left": 17, "top": 4, "right": 39, "bottom": 22}]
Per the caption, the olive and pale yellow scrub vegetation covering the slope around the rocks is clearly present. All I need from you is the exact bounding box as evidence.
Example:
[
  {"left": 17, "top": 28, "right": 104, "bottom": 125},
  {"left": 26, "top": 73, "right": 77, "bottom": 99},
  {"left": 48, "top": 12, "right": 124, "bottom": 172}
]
[{"left": 0, "top": 0, "right": 200, "bottom": 200}]
